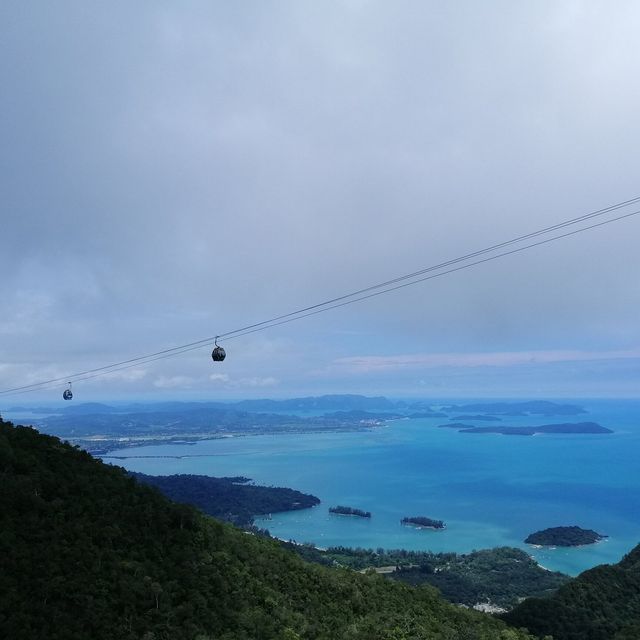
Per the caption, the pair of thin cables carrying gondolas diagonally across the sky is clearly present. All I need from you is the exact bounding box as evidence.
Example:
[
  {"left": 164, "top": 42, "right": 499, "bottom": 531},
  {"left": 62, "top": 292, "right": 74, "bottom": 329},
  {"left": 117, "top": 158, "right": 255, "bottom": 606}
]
[{"left": 0, "top": 196, "right": 640, "bottom": 399}]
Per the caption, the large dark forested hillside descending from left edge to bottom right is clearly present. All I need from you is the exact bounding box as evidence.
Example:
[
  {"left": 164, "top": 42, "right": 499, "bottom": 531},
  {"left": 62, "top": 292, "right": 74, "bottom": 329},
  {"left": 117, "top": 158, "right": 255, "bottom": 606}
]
[{"left": 0, "top": 420, "right": 528, "bottom": 640}]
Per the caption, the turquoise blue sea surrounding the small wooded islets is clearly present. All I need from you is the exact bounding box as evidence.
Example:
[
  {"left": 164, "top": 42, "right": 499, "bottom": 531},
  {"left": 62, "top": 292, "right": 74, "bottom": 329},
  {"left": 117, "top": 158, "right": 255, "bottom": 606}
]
[{"left": 105, "top": 400, "right": 640, "bottom": 575}]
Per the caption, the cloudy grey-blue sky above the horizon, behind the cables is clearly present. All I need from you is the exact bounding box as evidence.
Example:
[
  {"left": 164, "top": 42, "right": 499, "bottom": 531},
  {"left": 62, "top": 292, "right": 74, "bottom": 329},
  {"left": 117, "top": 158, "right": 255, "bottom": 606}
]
[{"left": 0, "top": 0, "right": 640, "bottom": 406}]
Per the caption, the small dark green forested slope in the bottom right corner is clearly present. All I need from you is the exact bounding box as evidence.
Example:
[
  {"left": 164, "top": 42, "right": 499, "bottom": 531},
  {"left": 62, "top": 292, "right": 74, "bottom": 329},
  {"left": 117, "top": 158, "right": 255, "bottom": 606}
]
[{"left": 504, "top": 546, "right": 640, "bottom": 640}]
